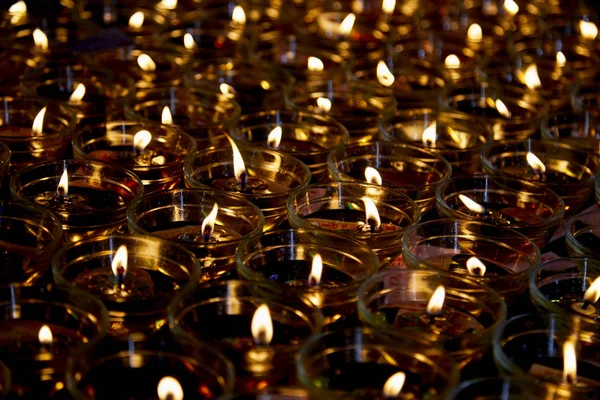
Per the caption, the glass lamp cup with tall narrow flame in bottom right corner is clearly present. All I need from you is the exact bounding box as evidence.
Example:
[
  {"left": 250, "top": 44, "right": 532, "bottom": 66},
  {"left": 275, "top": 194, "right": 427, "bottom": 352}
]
[{"left": 494, "top": 314, "right": 600, "bottom": 398}]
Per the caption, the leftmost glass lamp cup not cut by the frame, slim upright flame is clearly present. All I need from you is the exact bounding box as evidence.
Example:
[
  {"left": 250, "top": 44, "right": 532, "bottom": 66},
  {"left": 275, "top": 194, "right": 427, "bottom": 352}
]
[{"left": 10, "top": 160, "right": 144, "bottom": 242}]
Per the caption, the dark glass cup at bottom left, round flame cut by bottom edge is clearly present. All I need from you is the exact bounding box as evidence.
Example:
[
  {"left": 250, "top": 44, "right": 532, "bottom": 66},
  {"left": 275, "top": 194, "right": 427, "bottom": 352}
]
[{"left": 66, "top": 334, "right": 235, "bottom": 400}]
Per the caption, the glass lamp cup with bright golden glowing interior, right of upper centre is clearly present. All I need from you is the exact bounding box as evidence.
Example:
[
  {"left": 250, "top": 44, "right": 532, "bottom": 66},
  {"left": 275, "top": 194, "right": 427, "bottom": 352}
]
[{"left": 379, "top": 109, "right": 493, "bottom": 176}]
